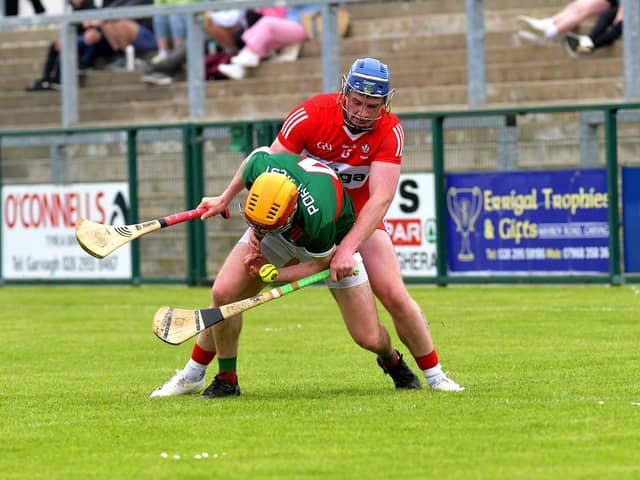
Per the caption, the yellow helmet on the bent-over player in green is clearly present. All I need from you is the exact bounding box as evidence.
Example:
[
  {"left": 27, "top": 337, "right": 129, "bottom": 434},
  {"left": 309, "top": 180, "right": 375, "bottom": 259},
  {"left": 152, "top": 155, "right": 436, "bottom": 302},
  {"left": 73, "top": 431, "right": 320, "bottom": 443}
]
[{"left": 244, "top": 172, "right": 298, "bottom": 235}]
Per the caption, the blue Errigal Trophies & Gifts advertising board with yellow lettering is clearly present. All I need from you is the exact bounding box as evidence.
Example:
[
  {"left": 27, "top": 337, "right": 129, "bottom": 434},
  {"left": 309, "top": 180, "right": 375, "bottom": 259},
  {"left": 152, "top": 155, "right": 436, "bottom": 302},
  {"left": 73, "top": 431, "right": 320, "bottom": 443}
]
[{"left": 446, "top": 169, "right": 609, "bottom": 275}]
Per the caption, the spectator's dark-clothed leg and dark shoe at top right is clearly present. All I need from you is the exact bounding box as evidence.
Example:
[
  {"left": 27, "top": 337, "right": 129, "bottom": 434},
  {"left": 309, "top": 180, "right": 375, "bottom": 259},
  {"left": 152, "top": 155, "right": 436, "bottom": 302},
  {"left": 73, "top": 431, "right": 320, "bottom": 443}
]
[{"left": 562, "top": 5, "right": 622, "bottom": 58}]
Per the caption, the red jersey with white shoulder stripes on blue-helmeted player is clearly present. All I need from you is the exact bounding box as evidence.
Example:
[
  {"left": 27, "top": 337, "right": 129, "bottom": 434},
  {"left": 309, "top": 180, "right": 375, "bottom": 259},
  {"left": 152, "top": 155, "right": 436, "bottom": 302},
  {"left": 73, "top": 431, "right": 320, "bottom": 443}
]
[{"left": 278, "top": 93, "right": 404, "bottom": 212}]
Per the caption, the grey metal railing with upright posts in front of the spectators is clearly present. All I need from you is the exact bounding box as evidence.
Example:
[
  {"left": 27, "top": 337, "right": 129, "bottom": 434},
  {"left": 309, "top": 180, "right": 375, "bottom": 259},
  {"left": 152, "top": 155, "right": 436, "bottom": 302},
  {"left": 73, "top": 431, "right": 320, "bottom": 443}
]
[{"left": 0, "top": 0, "right": 640, "bottom": 127}]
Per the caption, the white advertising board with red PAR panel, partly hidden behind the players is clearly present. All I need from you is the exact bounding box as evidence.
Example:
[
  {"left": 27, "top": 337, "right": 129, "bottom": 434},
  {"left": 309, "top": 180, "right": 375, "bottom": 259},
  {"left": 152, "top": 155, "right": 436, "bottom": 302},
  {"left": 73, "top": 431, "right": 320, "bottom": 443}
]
[{"left": 385, "top": 173, "right": 437, "bottom": 278}]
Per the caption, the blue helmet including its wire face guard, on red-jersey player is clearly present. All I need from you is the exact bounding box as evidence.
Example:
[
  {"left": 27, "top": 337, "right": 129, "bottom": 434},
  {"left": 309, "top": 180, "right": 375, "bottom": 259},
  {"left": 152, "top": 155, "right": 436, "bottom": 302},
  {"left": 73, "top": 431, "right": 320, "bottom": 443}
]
[{"left": 342, "top": 58, "right": 395, "bottom": 131}]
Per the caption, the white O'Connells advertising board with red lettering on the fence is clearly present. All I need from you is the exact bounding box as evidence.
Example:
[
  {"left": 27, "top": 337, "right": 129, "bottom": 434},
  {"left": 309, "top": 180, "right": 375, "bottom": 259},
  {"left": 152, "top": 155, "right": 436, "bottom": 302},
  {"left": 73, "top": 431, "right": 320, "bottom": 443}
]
[{"left": 2, "top": 182, "right": 131, "bottom": 280}]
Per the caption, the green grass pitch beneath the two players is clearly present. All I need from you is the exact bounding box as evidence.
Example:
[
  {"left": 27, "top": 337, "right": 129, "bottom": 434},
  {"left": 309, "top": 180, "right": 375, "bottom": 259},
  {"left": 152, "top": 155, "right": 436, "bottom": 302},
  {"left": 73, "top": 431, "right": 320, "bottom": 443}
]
[{"left": 0, "top": 286, "right": 640, "bottom": 480}]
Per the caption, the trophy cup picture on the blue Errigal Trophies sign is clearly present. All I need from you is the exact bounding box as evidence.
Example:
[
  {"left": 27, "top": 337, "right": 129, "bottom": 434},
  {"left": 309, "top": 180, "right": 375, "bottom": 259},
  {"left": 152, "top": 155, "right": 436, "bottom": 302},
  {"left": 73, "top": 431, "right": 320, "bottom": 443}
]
[{"left": 447, "top": 187, "right": 482, "bottom": 262}]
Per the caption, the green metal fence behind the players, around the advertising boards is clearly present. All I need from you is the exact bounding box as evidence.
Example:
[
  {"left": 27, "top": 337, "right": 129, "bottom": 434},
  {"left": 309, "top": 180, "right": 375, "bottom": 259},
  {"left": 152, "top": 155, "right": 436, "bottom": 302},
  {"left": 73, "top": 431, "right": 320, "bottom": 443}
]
[{"left": 0, "top": 103, "right": 640, "bottom": 285}]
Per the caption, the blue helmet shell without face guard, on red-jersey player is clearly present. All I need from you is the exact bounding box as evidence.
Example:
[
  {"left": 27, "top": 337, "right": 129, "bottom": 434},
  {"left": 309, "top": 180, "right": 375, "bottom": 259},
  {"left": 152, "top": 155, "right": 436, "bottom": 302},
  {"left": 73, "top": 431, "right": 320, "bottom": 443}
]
[{"left": 342, "top": 58, "right": 394, "bottom": 106}]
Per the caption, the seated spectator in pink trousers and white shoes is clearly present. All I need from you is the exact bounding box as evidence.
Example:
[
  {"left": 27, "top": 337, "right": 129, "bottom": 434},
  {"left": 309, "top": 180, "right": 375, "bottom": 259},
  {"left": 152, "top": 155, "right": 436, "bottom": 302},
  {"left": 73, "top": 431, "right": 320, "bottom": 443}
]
[{"left": 218, "top": 5, "right": 320, "bottom": 80}]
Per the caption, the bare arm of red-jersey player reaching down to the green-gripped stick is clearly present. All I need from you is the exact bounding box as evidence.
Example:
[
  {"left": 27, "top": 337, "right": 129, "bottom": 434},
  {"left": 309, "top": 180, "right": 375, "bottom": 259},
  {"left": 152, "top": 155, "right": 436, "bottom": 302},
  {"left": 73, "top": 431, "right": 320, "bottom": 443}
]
[{"left": 331, "top": 162, "right": 400, "bottom": 280}]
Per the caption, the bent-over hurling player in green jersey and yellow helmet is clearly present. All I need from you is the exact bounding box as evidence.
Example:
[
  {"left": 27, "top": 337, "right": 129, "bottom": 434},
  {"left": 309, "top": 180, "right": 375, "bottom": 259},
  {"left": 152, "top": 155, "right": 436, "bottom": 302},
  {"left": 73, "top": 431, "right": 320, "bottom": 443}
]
[{"left": 151, "top": 147, "right": 421, "bottom": 398}]
